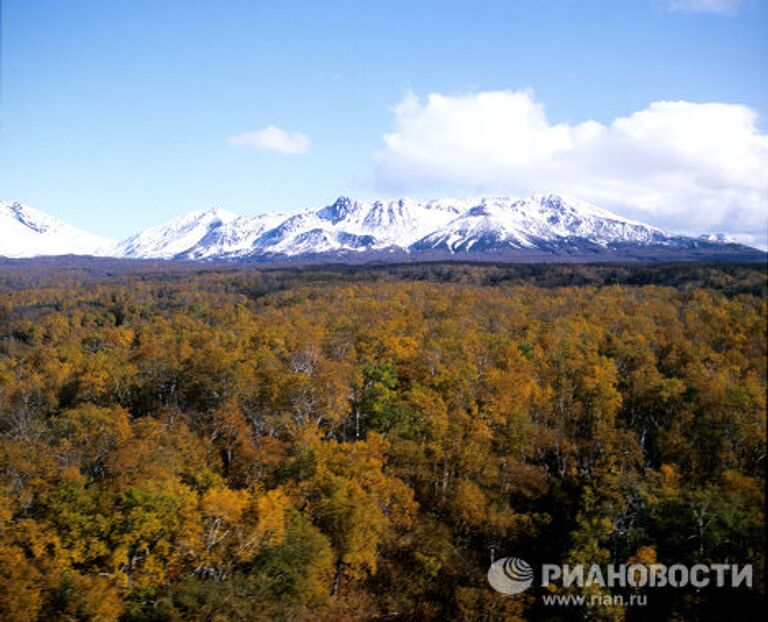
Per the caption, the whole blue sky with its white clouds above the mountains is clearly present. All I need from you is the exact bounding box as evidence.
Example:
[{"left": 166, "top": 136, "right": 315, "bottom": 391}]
[{"left": 0, "top": 0, "right": 768, "bottom": 244}]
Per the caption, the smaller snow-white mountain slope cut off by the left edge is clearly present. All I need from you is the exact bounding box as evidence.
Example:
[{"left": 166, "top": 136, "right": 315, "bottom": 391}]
[{"left": 0, "top": 201, "right": 114, "bottom": 257}]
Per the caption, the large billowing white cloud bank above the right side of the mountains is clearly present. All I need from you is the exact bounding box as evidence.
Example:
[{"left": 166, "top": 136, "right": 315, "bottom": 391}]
[{"left": 376, "top": 91, "right": 768, "bottom": 245}]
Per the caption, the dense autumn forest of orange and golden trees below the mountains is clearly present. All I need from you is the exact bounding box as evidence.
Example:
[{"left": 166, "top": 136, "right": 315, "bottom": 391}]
[{"left": 0, "top": 262, "right": 768, "bottom": 622}]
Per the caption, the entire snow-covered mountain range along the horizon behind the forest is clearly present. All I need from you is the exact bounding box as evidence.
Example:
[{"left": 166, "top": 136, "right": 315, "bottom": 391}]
[{"left": 0, "top": 194, "right": 765, "bottom": 262}]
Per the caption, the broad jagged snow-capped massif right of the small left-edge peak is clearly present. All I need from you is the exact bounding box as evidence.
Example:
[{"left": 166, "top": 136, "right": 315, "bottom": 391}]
[{"left": 105, "top": 194, "right": 748, "bottom": 261}]
